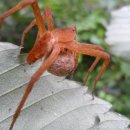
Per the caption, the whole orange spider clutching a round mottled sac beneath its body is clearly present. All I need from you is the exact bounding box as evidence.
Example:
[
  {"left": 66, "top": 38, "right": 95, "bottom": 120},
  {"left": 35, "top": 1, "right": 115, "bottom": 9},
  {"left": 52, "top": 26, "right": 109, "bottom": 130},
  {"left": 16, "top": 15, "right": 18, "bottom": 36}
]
[{"left": 0, "top": 0, "right": 110, "bottom": 130}]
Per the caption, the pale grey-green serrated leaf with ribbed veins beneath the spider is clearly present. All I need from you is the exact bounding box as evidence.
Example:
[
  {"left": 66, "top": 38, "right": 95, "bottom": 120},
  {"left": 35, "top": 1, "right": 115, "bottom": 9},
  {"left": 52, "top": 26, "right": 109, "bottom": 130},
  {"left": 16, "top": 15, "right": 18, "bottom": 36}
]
[{"left": 0, "top": 43, "right": 130, "bottom": 130}]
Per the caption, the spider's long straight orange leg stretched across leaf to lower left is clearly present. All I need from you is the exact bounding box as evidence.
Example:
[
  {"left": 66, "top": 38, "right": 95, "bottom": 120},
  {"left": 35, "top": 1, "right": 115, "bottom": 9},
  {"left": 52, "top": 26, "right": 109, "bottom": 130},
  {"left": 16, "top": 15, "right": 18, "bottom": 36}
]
[{"left": 9, "top": 45, "right": 60, "bottom": 130}]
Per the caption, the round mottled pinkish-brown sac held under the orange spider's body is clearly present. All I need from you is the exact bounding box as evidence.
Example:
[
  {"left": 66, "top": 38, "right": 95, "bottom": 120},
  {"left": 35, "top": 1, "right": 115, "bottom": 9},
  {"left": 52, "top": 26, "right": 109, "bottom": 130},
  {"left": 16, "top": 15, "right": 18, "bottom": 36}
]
[{"left": 48, "top": 52, "right": 75, "bottom": 76}]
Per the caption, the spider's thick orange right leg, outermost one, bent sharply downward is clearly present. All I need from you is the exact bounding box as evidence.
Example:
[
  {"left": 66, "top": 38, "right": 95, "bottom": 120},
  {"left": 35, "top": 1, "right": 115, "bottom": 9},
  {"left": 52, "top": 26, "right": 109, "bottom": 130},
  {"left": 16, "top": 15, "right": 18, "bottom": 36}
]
[{"left": 61, "top": 42, "right": 110, "bottom": 99}]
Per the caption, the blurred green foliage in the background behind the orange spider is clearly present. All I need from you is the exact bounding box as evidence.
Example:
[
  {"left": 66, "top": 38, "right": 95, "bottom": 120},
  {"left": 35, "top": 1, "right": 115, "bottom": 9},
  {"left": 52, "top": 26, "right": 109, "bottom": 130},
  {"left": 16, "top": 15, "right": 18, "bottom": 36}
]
[{"left": 0, "top": 0, "right": 130, "bottom": 118}]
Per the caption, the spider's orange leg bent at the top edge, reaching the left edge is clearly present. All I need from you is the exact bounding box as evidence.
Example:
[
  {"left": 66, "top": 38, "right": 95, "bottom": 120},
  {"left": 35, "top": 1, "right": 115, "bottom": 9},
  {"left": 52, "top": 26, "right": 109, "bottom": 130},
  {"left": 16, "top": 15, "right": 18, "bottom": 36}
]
[{"left": 0, "top": 0, "right": 46, "bottom": 36}]
